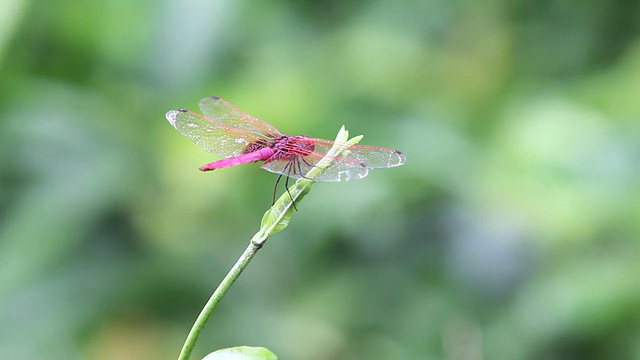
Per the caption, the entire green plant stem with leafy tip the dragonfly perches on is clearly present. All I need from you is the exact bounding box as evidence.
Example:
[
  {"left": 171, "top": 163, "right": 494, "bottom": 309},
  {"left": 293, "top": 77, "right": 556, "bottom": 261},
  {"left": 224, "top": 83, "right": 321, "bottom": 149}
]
[{"left": 178, "top": 126, "right": 362, "bottom": 360}]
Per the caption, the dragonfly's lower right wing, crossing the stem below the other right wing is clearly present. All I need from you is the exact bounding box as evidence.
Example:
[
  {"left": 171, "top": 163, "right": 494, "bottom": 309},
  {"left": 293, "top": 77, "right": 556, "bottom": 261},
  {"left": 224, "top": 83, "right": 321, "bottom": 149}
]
[{"left": 261, "top": 152, "right": 369, "bottom": 182}]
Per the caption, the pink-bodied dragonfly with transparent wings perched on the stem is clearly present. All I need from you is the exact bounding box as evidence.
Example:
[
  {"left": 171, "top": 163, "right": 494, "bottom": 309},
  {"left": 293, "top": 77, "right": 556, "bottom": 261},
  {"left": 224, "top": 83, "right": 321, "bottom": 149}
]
[{"left": 166, "top": 96, "right": 406, "bottom": 200}]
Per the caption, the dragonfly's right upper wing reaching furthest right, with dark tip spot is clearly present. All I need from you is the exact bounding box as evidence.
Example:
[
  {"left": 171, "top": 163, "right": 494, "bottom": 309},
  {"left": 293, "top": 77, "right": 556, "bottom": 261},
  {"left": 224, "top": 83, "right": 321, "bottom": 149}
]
[{"left": 306, "top": 139, "right": 407, "bottom": 169}]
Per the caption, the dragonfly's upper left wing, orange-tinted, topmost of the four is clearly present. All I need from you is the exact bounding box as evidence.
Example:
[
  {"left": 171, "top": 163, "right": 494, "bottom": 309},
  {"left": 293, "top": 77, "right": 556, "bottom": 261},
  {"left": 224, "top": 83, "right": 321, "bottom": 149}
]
[{"left": 199, "top": 96, "right": 280, "bottom": 138}]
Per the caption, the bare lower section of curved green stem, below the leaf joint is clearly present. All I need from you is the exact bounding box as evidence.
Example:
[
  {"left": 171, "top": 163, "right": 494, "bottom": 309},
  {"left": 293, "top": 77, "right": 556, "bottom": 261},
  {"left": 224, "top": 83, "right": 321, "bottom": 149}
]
[{"left": 178, "top": 241, "right": 262, "bottom": 360}]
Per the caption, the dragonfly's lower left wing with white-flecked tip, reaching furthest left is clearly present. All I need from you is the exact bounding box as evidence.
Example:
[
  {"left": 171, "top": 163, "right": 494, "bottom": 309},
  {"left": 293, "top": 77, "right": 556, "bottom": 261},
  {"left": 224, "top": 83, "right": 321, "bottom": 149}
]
[{"left": 166, "top": 109, "right": 258, "bottom": 157}]
